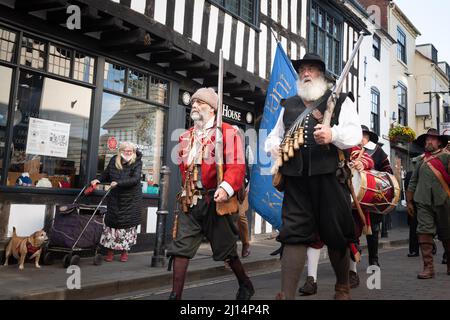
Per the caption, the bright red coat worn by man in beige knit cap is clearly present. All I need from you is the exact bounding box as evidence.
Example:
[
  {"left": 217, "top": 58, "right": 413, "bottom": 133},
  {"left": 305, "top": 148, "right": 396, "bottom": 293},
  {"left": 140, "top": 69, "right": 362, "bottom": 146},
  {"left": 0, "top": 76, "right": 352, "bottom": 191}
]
[{"left": 178, "top": 123, "right": 245, "bottom": 192}]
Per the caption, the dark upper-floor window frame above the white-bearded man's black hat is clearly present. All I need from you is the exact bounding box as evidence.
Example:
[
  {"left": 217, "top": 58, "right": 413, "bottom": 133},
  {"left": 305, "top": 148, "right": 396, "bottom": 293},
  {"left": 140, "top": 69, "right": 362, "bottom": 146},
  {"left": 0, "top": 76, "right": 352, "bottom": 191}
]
[{"left": 307, "top": 0, "right": 344, "bottom": 77}]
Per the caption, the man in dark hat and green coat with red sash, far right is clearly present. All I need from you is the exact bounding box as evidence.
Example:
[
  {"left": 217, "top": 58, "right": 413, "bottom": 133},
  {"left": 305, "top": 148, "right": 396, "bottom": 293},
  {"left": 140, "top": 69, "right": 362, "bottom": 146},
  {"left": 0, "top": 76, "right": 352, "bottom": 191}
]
[{"left": 406, "top": 129, "right": 450, "bottom": 279}]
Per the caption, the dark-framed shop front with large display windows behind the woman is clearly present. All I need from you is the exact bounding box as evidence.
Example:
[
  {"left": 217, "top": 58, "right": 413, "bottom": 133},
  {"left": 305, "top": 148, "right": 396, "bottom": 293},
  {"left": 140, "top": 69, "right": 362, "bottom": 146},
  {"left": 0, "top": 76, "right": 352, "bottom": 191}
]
[{"left": 0, "top": 23, "right": 171, "bottom": 255}]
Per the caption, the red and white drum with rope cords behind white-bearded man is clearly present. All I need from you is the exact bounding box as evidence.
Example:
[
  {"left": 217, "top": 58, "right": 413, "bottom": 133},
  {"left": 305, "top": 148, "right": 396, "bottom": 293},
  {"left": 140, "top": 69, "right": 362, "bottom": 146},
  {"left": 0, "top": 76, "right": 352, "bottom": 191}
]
[{"left": 352, "top": 169, "right": 400, "bottom": 214}]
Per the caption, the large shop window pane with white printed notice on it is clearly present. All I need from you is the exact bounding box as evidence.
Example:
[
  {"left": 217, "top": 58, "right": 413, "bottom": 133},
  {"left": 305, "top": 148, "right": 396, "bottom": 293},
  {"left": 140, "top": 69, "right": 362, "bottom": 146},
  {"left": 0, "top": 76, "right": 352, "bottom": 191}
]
[{"left": 7, "top": 72, "right": 92, "bottom": 188}]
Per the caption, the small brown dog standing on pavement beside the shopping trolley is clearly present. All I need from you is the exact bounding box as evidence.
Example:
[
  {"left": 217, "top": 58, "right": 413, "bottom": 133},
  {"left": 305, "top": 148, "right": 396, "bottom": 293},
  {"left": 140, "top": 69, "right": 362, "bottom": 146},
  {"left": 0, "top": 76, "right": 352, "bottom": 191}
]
[{"left": 4, "top": 227, "right": 47, "bottom": 270}]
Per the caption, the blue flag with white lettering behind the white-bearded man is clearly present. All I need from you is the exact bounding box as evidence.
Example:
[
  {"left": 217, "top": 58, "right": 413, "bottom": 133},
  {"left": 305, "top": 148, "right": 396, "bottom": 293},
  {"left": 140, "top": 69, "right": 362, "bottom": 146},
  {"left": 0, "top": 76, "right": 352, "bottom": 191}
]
[{"left": 249, "top": 43, "right": 297, "bottom": 230}]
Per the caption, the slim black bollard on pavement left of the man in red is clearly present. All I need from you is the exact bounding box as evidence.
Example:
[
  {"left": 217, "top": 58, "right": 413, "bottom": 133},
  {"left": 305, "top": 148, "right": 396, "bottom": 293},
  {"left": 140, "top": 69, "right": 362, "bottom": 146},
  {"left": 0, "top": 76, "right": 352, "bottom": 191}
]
[{"left": 151, "top": 166, "right": 170, "bottom": 267}]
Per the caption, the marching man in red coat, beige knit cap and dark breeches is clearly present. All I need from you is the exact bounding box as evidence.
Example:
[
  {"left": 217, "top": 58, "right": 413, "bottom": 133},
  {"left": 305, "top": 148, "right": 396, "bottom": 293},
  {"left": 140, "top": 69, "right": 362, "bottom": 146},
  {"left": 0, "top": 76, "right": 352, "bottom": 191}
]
[{"left": 167, "top": 88, "right": 254, "bottom": 300}]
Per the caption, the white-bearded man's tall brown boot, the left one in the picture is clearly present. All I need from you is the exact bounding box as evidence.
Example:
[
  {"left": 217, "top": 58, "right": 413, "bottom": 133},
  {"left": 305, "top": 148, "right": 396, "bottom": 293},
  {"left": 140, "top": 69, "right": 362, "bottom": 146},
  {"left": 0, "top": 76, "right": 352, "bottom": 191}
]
[{"left": 276, "top": 244, "right": 307, "bottom": 300}]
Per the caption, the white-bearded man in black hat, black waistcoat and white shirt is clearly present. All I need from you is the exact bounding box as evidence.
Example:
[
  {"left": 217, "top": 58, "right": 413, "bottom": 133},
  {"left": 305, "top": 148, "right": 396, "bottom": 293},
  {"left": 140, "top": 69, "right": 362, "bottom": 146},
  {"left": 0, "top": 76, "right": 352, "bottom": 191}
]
[{"left": 265, "top": 54, "right": 362, "bottom": 299}]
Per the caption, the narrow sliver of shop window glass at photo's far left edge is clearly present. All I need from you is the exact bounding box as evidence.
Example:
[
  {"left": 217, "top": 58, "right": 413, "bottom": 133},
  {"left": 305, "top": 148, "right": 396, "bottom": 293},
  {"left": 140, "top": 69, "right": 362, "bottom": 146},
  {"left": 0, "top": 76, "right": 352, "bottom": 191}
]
[{"left": 0, "top": 66, "right": 12, "bottom": 179}]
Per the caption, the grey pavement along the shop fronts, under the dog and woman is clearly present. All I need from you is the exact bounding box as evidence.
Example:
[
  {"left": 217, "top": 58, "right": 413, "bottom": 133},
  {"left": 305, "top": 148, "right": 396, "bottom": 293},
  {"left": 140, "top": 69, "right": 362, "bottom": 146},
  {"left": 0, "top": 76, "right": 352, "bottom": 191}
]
[{"left": 0, "top": 227, "right": 409, "bottom": 300}]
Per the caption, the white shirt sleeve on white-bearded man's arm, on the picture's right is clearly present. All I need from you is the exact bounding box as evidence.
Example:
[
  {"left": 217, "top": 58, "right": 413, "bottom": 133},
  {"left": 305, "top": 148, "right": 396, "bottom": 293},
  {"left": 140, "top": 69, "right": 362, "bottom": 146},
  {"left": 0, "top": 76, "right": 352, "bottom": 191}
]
[{"left": 331, "top": 98, "right": 362, "bottom": 149}]
